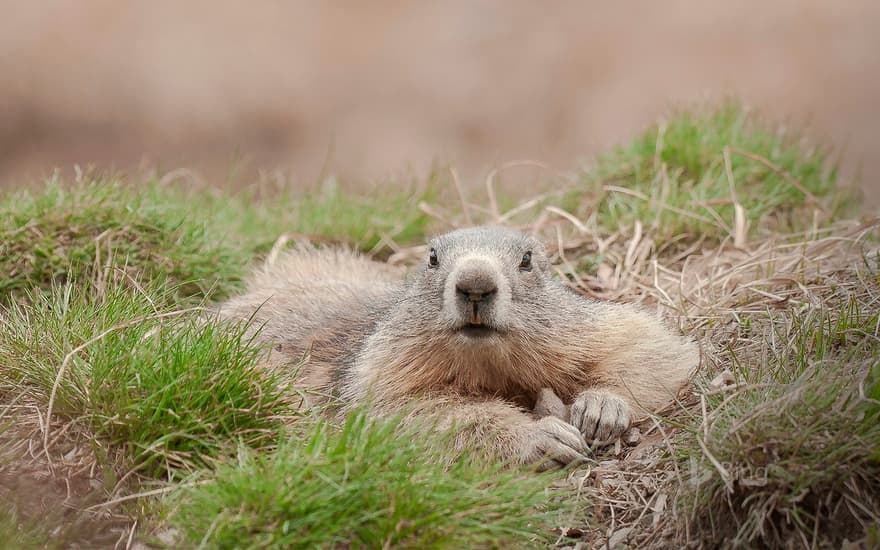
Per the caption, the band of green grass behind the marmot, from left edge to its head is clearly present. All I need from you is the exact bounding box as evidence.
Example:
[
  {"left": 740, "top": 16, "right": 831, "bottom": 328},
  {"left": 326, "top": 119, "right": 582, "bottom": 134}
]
[{"left": 0, "top": 177, "right": 437, "bottom": 303}]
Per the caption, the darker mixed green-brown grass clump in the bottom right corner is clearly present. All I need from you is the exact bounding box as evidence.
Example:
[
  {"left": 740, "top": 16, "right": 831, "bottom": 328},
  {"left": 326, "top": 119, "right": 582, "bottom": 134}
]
[{"left": 681, "top": 302, "right": 880, "bottom": 547}]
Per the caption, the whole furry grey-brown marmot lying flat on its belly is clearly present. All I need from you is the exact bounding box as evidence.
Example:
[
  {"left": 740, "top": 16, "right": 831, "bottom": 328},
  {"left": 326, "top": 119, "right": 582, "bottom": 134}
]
[{"left": 220, "top": 227, "right": 698, "bottom": 466}]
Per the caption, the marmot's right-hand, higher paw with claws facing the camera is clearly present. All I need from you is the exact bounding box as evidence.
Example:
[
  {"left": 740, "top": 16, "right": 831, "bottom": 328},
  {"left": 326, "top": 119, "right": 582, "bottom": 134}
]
[{"left": 569, "top": 389, "right": 631, "bottom": 445}]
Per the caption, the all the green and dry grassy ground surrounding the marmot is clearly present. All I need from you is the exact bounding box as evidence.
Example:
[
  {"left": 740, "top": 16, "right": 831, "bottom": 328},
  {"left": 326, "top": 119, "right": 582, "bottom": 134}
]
[{"left": 0, "top": 103, "right": 880, "bottom": 548}]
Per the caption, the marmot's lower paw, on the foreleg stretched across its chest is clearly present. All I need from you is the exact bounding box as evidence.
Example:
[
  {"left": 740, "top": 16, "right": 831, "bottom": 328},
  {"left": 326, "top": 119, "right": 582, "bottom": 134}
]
[{"left": 519, "top": 416, "right": 588, "bottom": 470}]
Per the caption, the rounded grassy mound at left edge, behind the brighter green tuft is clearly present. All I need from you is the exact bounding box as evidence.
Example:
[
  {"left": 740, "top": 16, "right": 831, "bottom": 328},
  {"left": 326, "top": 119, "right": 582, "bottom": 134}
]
[{"left": 0, "top": 180, "right": 248, "bottom": 300}]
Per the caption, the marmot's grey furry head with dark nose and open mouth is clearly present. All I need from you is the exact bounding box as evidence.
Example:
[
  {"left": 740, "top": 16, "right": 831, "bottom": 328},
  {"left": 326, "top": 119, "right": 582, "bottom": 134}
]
[{"left": 410, "top": 227, "right": 550, "bottom": 345}]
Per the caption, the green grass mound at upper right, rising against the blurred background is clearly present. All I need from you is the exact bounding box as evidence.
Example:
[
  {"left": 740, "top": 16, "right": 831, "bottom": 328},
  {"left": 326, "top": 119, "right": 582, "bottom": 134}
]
[{"left": 564, "top": 101, "right": 846, "bottom": 242}]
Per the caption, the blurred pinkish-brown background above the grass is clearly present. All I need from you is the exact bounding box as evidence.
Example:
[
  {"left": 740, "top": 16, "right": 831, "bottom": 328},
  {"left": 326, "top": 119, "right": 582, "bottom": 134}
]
[{"left": 0, "top": 0, "right": 880, "bottom": 204}]
